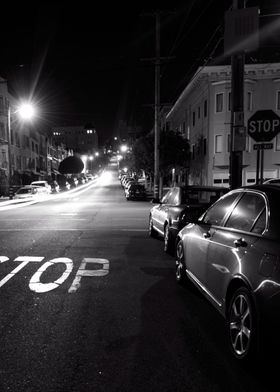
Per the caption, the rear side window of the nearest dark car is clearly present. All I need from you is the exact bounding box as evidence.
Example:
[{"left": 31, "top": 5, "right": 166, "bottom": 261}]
[{"left": 225, "top": 192, "right": 265, "bottom": 231}]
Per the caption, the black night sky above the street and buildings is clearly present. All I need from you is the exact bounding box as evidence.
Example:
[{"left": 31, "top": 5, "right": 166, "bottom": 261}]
[{"left": 0, "top": 0, "right": 277, "bottom": 144}]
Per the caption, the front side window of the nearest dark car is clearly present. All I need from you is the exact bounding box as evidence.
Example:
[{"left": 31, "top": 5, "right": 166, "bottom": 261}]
[{"left": 202, "top": 192, "right": 240, "bottom": 226}]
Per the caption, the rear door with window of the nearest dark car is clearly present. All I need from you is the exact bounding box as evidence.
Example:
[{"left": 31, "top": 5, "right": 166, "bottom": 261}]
[{"left": 206, "top": 191, "right": 267, "bottom": 307}]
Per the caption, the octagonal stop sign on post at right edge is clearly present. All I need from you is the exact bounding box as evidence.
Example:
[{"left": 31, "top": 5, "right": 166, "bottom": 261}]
[{"left": 248, "top": 110, "right": 280, "bottom": 142}]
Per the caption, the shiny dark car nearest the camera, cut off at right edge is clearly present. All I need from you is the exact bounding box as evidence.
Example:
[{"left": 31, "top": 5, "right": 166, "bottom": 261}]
[{"left": 176, "top": 185, "right": 280, "bottom": 363}]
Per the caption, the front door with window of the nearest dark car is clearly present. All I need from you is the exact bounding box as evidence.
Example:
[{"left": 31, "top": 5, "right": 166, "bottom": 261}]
[{"left": 183, "top": 194, "right": 240, "bottom": 291}]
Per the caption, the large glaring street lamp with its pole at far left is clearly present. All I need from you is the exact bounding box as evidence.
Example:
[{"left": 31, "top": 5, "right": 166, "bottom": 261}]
[{"left": 8, "top": 103, "right": 35, "bottom": 199}]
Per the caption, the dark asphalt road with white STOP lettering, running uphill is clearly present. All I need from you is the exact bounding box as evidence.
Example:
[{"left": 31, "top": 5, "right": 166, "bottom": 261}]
[{"left": 0, "top": 166, "right": 278, "bottom": 392}]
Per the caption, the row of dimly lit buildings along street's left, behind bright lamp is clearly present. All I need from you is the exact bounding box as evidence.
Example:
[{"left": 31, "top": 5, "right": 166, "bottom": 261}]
[{"left": 0, "top": 78, "right": 72, "bottom": 196}]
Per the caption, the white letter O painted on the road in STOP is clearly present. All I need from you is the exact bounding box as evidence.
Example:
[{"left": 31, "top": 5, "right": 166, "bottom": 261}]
[{"left": 29, "top": 257, "right": 73, "bottom": 293}]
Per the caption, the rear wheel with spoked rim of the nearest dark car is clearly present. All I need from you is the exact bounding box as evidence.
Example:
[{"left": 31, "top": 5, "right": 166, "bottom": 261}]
[{"left": 227, "top": 287, "right": 258, "bottom": 361}]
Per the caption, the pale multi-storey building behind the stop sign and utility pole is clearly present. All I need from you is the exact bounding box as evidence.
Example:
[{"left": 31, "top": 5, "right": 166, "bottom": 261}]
[{"left": 165, "top": 63, "right": 280, "bottom": 186}]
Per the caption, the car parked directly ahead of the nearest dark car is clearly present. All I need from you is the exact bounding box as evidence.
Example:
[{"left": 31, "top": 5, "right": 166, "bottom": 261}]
[{"left": 149, "top": 185, "right": 229, "bottom": 253}]
